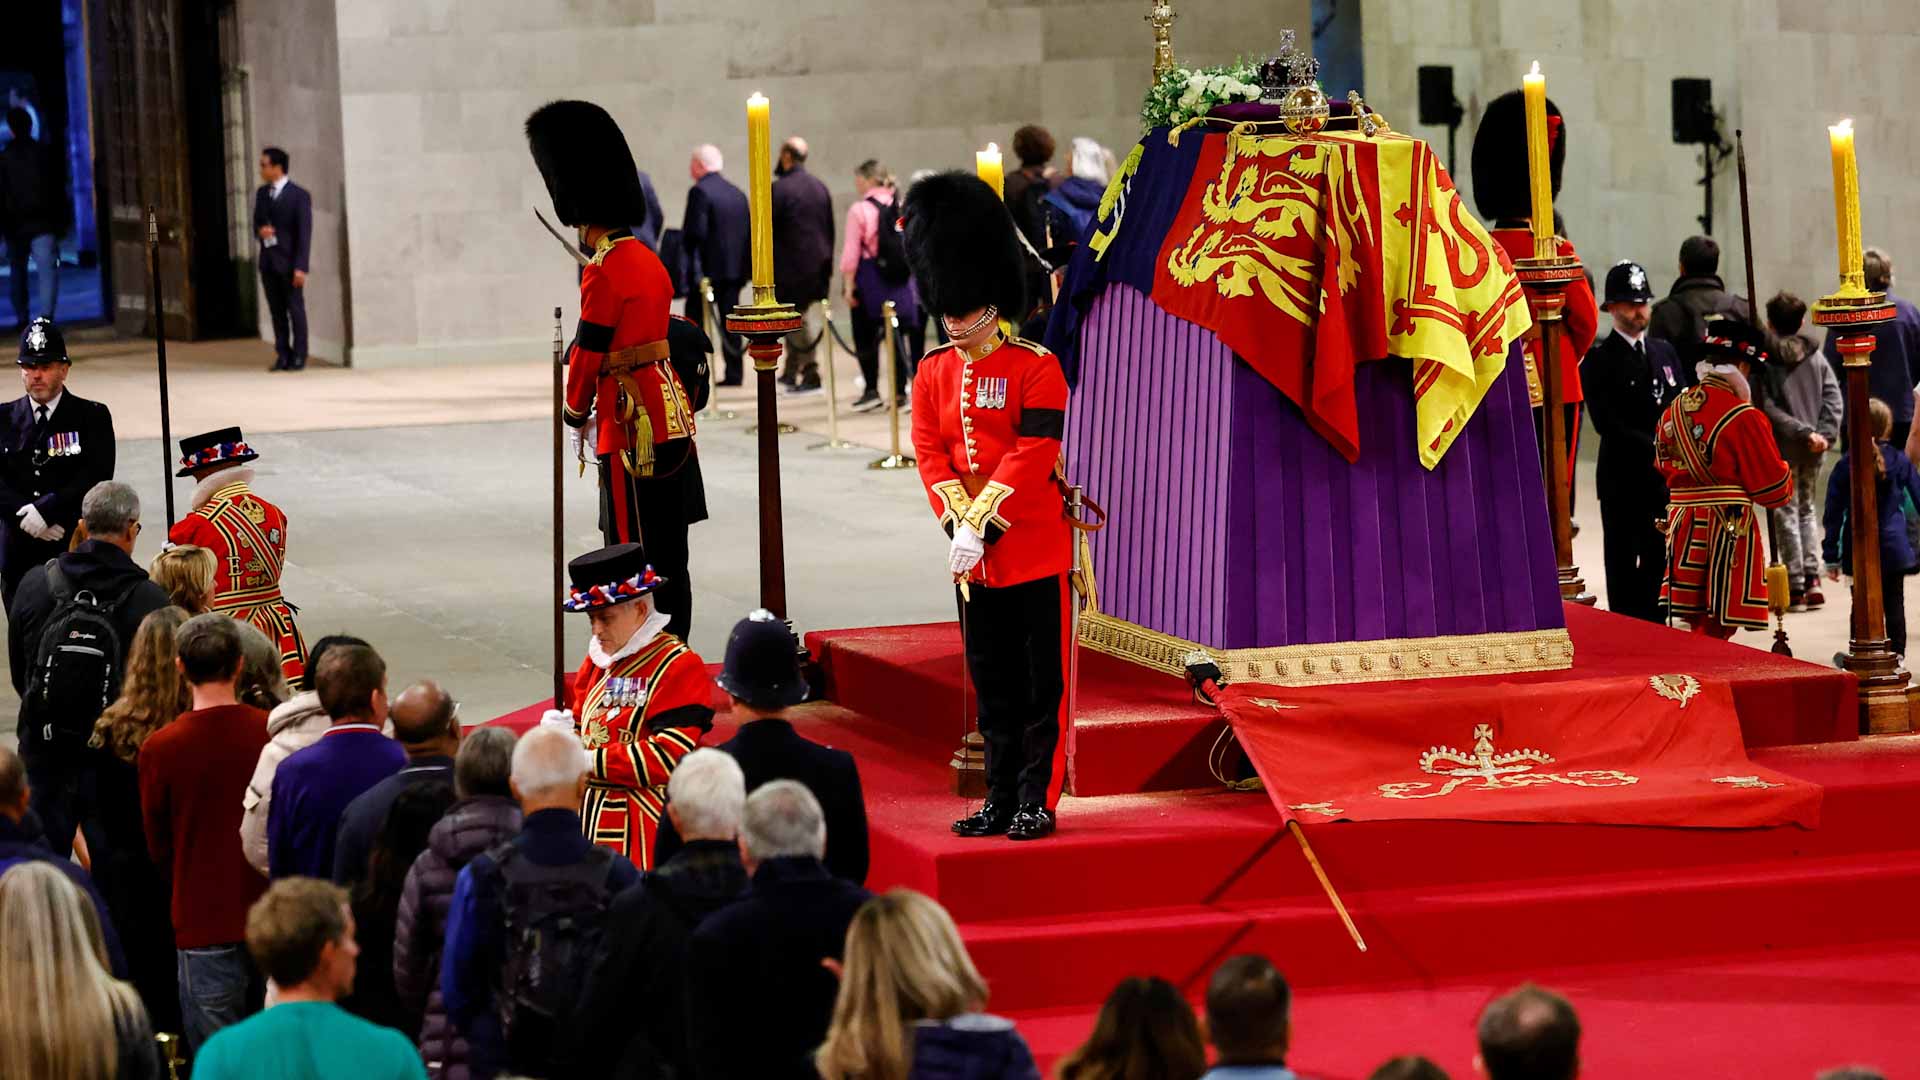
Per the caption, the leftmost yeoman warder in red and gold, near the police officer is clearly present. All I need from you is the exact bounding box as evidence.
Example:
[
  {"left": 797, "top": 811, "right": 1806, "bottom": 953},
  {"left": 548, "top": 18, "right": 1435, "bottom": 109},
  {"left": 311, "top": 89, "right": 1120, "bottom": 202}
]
[{"left": 167, "top": 427, "right": 307, "bottom": 676}]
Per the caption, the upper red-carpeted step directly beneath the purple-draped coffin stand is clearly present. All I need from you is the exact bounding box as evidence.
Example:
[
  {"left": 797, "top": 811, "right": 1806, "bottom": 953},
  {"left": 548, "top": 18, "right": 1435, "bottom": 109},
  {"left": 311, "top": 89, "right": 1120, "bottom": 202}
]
[{"left": 806, "top": 603, "right": 1859, "bottom": 796}]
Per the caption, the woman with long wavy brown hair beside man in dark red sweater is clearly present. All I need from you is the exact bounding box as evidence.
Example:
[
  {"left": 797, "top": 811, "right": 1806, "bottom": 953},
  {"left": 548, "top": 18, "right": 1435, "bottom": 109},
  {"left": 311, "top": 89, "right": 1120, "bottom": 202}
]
[{"left": 86, "top": 607, "right": 188, "bottom": 1032}]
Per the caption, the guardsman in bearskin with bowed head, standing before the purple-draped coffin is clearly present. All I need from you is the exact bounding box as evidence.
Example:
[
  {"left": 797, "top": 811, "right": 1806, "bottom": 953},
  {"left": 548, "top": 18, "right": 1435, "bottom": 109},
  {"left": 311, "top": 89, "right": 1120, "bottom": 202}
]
[{"left": 902, "top": 173, "right": 1073, "bottom": 840}]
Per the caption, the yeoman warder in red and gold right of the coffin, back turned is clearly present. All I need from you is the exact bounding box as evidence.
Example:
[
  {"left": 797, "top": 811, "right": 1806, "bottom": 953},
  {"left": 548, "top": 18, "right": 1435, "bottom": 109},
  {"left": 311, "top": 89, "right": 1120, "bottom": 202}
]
[{"left": 1653, "top": 319, "right": 1793, "bottom": 638}]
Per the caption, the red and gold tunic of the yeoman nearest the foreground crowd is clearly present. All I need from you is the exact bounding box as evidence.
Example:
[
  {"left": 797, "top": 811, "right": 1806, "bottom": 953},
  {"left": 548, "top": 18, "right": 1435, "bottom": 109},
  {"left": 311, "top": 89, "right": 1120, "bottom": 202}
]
[{"left": 572, "top": 634, "right": 712, "bottom": 871}]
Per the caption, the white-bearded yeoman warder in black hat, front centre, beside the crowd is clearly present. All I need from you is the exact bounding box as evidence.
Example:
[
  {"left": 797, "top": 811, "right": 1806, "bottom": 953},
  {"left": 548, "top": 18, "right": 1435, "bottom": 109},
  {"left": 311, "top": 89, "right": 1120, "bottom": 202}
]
[{"left": 540, "top": 544, "right": 714, "bottom": 871}]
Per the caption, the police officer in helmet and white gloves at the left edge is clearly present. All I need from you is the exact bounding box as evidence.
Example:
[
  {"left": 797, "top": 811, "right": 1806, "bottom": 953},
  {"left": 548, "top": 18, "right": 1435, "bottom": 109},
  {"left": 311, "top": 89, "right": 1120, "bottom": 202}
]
[{"left": 0, "top": 317, "right": 113, "bottom": 607}]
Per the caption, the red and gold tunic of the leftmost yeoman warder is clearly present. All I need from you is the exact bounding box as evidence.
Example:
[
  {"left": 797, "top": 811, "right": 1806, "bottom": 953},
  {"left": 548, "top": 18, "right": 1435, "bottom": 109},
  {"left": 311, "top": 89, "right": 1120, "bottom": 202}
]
[{"left": 167, "top": 479, "right": 307, "bottom": 686}]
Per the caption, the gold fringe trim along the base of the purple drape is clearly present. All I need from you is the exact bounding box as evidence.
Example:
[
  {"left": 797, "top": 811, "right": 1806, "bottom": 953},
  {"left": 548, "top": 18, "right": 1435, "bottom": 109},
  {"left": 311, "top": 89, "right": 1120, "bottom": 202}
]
[{"left": 1079, "top": 611, "right": 1572, "bottom": 686}]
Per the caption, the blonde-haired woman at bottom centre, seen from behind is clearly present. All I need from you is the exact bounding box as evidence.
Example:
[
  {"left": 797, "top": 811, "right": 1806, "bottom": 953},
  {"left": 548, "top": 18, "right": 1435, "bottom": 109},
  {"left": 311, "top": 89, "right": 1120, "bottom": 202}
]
[{"left": 814, "top": 888, "right": 1041, "bottom": 1080}]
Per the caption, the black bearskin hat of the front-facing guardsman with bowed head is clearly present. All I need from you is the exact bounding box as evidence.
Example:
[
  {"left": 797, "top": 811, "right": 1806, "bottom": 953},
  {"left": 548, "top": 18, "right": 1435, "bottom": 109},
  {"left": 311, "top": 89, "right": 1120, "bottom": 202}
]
[{"left": 900, "top": 169, "right": 1027, "bottom": 321}]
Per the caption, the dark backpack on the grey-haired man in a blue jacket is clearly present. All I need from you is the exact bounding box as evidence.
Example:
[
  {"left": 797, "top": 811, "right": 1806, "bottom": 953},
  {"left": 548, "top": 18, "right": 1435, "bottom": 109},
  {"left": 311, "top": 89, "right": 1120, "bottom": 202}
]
[{"left": 493, "top": 842, "right": 612, "bottom": 1076}]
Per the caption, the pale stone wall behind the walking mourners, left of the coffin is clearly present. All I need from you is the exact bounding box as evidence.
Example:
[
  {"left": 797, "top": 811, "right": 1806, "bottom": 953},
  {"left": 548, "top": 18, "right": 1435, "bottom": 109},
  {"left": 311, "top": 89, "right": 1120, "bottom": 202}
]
[{"left": 334, "top": 0, "right": 1308, "bottom": 367}]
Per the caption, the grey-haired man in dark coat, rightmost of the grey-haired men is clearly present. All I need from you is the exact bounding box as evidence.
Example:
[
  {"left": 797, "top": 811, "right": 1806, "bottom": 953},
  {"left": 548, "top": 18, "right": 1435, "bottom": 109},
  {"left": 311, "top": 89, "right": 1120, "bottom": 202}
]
[{"left": 691, "top": 780, "right": 872, "bottom": 1080}]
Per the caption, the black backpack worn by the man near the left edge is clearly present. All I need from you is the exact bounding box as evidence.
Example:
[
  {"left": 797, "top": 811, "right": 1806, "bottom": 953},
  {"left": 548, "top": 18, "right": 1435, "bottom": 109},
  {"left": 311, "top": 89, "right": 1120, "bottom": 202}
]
[{"left": 27, "top": 557, "right": 144, "bottom": 748}]
